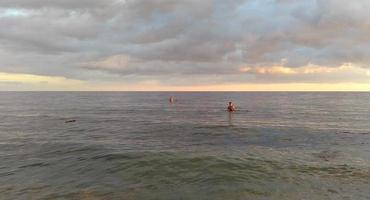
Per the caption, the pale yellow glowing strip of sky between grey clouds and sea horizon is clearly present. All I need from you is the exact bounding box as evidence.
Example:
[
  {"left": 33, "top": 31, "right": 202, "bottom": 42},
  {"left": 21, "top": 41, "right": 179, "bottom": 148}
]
[{"left": 0, "top": 70, "right": 370, "bottom": 91}]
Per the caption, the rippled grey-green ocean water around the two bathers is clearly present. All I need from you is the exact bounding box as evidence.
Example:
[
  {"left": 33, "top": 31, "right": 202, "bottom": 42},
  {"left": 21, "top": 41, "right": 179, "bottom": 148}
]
[{"left": 0, "top": 92, "right": 370, "bottom": 200}]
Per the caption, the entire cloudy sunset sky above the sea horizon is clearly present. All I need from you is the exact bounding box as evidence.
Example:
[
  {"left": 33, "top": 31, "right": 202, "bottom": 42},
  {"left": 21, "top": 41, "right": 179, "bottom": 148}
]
[{"left": 0, "top": 0, "right": 370, "bottom": 91}]
